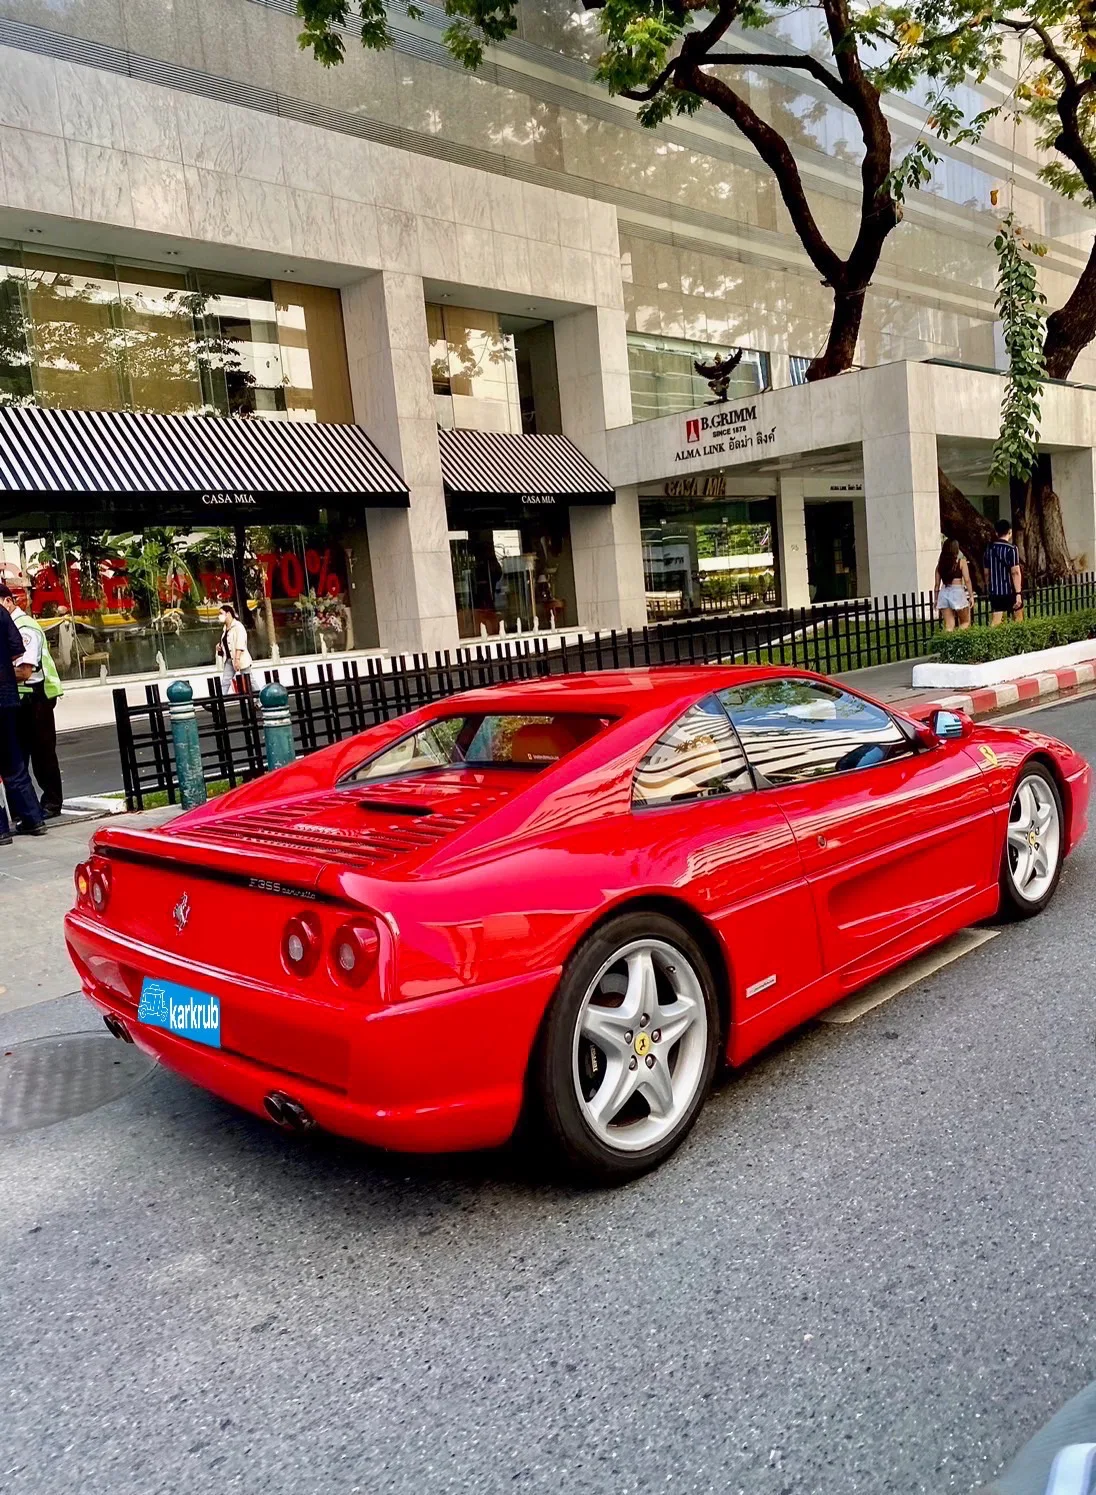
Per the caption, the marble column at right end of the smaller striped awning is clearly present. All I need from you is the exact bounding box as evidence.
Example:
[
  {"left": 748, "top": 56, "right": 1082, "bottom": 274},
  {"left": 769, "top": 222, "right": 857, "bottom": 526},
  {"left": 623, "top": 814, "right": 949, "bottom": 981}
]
[{"left": 555, "top": 306, "right": 647, "bottom": 628}]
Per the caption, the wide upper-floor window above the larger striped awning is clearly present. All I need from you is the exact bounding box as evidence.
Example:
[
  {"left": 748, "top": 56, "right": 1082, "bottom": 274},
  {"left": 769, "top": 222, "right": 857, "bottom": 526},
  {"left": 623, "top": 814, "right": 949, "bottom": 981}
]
[{"left": 0, "top": 244, "right": 353, "bottom": 420}]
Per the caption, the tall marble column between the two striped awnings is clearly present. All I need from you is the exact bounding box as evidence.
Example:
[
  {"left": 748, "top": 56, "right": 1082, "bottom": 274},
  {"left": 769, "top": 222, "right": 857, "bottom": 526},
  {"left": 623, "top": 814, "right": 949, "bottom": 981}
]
[{"left": 342, "top": 271, "right": 458, "bottom": 655}]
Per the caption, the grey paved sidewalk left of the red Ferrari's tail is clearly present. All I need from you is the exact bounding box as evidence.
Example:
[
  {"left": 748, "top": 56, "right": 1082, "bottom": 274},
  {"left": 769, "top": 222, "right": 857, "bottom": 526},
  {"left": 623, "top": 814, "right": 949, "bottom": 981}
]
[{"left": 0, "top": 807, "right": 179, "bottom": 1014}]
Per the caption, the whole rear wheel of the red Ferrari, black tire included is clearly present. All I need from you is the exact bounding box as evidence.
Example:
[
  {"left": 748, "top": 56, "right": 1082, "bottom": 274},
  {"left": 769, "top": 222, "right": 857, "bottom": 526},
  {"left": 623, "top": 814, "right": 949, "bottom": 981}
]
[{"left": 531, "top": 913, "right": 721, "bottom": 1184}]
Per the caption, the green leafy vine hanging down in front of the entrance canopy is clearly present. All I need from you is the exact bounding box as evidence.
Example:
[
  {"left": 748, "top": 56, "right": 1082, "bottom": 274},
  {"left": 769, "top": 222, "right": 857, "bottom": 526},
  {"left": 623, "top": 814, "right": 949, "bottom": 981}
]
[{"left": 990, "top": 212, "right": 1047, "bottom": 483}]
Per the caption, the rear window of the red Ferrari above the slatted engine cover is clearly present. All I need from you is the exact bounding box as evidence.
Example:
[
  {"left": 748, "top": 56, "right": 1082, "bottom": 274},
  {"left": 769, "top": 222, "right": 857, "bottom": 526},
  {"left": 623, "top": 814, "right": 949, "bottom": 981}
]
[{"left": 344, "top": 712, "right": 609, "bottom": 783}]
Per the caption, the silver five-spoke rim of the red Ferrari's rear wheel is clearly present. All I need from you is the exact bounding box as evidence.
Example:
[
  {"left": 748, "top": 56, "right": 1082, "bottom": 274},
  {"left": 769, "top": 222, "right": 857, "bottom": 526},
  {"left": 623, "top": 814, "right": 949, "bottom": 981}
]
[{"left": 573, "top": 939, "right": 709, "bottom": 1153}]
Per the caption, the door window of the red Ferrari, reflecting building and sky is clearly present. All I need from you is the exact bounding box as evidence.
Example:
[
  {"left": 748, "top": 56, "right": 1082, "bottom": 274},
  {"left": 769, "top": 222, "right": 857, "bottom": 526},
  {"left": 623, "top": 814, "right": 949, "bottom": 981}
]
[{"left": 719, "top": 680, "right": 912, "bottom": 785}]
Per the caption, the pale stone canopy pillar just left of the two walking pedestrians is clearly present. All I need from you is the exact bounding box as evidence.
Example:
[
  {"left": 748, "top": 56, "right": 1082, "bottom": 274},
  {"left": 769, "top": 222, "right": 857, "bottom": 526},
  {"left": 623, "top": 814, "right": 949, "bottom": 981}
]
[{"left": 860, "top": 363, "right": 940, "bottom": 597}]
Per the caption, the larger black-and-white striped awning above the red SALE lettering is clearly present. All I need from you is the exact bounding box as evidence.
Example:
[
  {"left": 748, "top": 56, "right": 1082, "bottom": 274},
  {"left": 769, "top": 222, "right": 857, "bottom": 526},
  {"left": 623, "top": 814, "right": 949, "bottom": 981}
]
[{"left": 0, "top": 405, "right": 408, "bottom": 514}]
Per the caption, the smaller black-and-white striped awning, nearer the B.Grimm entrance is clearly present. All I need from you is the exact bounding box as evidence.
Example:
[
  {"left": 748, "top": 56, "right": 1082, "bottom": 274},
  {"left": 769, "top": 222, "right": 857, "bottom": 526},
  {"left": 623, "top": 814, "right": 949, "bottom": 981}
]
[{"left": 438, "top": 431, "right": 616, "bottom": 507}]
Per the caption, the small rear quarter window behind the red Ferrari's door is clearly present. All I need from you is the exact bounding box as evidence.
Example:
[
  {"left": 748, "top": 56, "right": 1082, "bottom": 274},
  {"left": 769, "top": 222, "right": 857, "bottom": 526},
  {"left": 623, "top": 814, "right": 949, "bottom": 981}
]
[{"left": 632, "top": 695, "right": 754, "bottom": 804}]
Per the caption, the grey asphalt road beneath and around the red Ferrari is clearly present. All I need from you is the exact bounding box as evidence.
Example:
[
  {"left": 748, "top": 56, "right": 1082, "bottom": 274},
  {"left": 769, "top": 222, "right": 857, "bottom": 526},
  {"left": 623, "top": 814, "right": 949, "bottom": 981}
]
[{"left": 0, "top": 698, "right": 1096, "bottom": 1495}]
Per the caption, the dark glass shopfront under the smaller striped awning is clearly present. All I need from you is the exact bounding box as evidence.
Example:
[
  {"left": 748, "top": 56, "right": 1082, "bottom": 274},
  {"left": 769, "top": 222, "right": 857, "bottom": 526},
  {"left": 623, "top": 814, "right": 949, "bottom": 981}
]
[{"left": 449, "top": 507, "right": 577, "bottom": 638}]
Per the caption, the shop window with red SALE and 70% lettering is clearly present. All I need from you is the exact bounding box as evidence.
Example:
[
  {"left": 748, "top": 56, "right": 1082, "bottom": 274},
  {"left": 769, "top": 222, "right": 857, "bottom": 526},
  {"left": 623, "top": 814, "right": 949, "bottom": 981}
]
[{"left": 0, "top": 522, "right": 354, "bottom": 680}]
